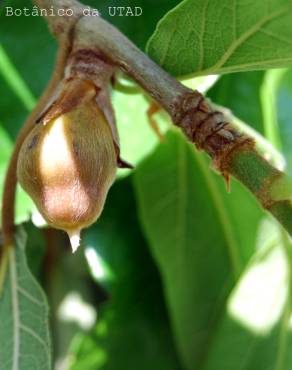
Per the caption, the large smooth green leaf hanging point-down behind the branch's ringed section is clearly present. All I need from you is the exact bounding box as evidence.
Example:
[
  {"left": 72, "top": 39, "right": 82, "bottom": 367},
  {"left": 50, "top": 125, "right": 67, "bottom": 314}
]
[{"left": 134, "top": 132, "right": 263, "bottom": 370}]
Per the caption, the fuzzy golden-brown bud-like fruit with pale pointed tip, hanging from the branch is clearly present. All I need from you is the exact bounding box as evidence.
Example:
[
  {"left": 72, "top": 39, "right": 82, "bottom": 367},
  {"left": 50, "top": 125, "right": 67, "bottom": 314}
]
[{"left": 17, "top": 79, "right": 117, "bottom": 251}]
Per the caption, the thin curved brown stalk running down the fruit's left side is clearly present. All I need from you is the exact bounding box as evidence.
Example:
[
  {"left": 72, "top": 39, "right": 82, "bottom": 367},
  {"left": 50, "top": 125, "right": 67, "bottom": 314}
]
[{"left": 2, "top": 40, "right": 70, "bottom": 246}]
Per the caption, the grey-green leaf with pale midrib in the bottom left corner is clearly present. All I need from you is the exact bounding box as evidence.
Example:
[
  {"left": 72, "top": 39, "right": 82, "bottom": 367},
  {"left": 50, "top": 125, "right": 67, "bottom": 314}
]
[{"left": 0, "top": 230, "right": 51, "bottom": 370}]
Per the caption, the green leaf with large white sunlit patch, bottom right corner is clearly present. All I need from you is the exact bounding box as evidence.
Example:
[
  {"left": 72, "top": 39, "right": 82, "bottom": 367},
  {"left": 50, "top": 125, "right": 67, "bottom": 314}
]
[{"left": 202, "top": 219, "right": 292, "bottom": 370}]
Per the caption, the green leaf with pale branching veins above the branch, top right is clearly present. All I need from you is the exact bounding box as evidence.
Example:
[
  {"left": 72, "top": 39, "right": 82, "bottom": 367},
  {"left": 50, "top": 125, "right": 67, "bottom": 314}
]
[{"left": 147, "top": 0, "right": 292, "bottom": 76}]
